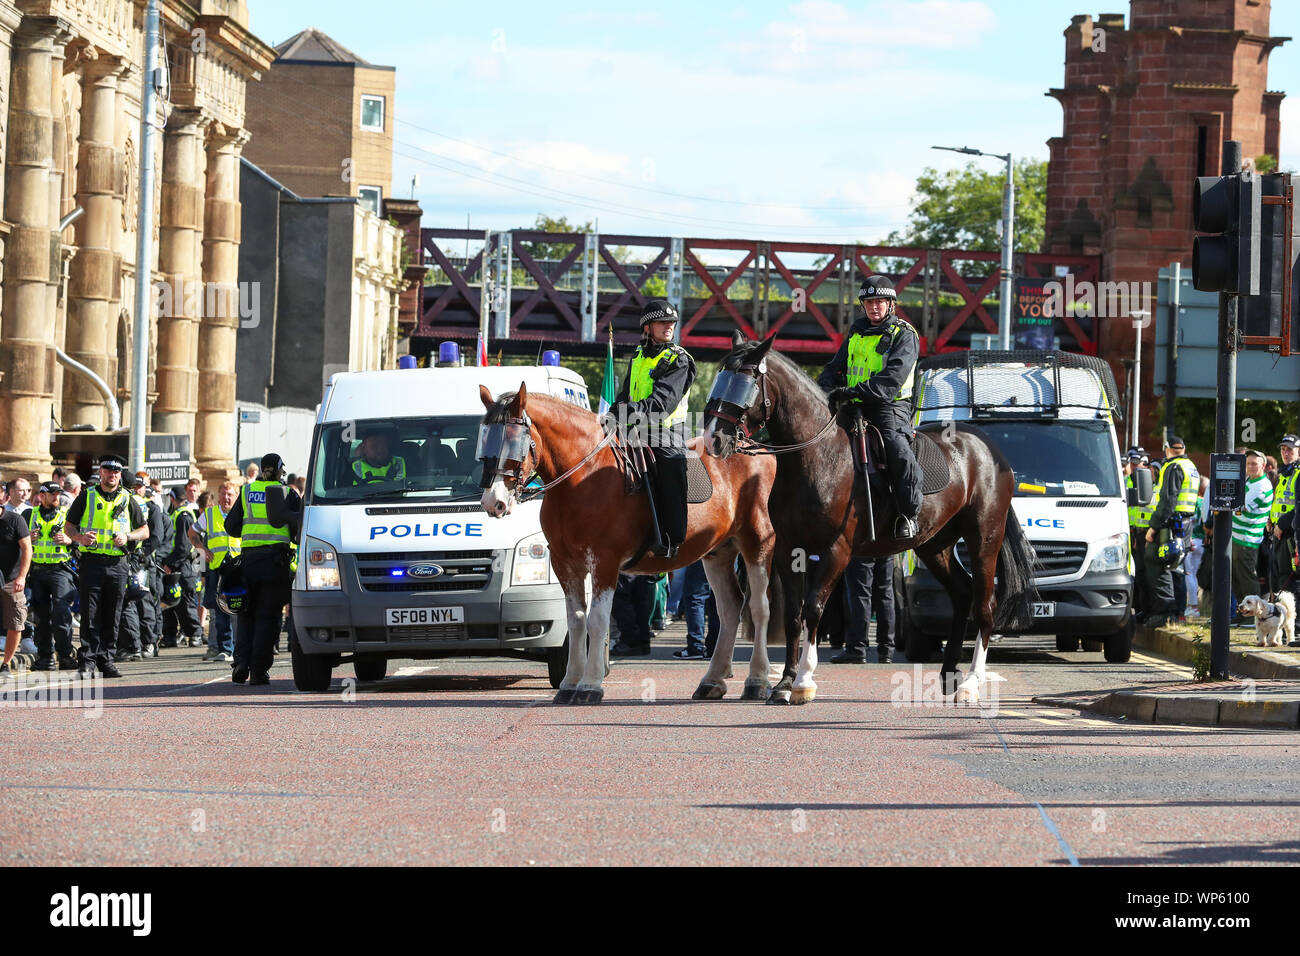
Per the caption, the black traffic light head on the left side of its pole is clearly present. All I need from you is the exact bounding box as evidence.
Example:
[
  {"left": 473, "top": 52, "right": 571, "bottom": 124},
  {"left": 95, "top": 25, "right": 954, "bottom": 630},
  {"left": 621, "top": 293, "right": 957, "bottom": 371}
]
[{"left": 1192, "top": 169, "right": 1260, "bottom": 295}]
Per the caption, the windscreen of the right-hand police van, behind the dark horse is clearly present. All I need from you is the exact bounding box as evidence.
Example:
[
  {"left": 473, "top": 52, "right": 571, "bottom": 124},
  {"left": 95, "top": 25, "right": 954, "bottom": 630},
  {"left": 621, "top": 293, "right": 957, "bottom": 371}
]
[{"left": 979, "top": 420, "right": 1119, "bottom": 498}]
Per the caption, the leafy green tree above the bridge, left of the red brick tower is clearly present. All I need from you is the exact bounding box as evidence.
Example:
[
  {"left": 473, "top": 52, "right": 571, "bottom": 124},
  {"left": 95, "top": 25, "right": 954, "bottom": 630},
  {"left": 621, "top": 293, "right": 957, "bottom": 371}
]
[{"left": 885, "top": 159, "right": 1048, "bottom": 252}]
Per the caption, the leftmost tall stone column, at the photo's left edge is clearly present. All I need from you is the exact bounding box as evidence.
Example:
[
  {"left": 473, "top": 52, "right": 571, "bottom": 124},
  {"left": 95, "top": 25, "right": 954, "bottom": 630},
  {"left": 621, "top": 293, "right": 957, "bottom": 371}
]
[{"left": 0, "top": 17, "right": 73, "bottom": 486}]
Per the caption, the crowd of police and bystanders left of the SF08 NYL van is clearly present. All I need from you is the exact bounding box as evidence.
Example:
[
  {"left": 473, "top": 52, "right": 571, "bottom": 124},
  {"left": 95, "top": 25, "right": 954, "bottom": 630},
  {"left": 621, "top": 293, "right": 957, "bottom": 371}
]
[{"left": 0, "top": 455, "right": 306, "bottom": 684}]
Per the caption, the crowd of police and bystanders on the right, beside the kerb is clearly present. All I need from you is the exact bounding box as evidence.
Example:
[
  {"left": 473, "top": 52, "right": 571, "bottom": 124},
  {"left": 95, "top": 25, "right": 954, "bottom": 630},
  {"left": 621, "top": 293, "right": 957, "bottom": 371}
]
[{"left": 1125, "top": 434, "right": 1300, "bottom": 639}]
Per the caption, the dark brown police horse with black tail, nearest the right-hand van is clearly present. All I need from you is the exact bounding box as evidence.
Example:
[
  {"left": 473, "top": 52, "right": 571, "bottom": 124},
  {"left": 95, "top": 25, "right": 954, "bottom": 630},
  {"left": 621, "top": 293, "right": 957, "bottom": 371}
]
[{"left": 703, "top": 333, "right": 1037, "bottom": 704}]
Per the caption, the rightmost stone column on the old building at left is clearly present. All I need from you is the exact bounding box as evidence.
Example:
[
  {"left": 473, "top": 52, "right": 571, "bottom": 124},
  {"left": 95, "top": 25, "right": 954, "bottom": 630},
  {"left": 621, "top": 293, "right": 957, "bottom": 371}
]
[{"left": 194, "top": 124, "right": 246, "bottom": 488}]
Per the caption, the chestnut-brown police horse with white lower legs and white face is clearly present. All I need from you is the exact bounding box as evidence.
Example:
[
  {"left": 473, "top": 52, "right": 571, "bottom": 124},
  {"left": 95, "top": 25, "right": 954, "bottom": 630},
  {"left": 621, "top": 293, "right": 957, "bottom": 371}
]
[{"left": 477, "top": 384, "right": 776, "bottom": 704}]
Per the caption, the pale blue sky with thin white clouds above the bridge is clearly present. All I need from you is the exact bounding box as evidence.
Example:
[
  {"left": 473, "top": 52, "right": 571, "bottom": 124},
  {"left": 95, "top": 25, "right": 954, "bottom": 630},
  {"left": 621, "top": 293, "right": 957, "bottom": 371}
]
[{"left": 248, "top": 0, "right": 1300, "bottom": 251}]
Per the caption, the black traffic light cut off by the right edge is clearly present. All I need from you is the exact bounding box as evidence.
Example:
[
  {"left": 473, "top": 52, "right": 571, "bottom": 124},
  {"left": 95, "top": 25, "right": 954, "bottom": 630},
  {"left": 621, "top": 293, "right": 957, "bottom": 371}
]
[{"left": 1238, "top": 173, "right": 1300, "bottom": 355}]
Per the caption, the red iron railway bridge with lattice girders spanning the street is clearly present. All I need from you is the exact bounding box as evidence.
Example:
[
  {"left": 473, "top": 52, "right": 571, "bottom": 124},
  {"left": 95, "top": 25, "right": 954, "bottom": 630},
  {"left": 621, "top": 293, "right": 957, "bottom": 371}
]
[{"left": 411, "top": 229, "right": 1100, "bottom": 362}]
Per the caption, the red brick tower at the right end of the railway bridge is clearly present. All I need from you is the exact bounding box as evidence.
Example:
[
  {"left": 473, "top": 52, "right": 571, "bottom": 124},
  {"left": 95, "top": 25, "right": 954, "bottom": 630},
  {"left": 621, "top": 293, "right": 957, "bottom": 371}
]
[{"left": 1045, "top": 0, "right": 1290, "bottom": 440}]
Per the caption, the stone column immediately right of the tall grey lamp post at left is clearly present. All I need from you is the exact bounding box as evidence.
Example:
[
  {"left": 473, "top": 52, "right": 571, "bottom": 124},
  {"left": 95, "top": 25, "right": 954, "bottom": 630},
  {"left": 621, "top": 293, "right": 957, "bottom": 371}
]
[{"left": 150, "top": 109, "right": 211, "bottom": 442}]
